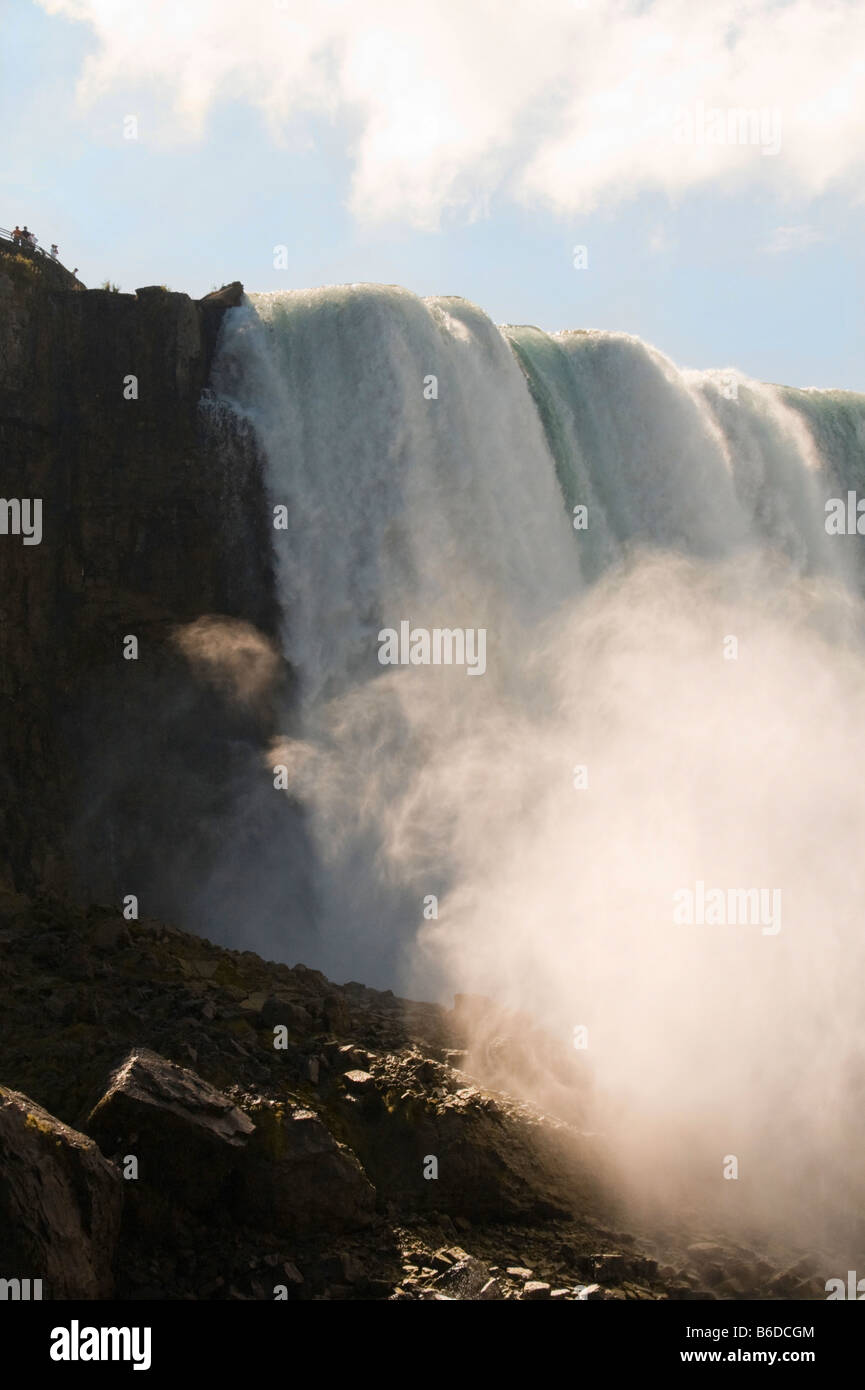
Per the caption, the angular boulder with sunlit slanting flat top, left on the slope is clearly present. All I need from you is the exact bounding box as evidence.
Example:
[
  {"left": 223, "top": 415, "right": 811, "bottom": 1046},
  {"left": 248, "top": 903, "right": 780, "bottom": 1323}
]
[{"left": 86, "top": 1048, "right": 254, "bottom": 1211}]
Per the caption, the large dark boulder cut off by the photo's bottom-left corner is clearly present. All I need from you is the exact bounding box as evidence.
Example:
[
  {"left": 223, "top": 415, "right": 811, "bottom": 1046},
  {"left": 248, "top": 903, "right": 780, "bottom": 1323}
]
[{"left": 0, "top": 1086, "right": 122, "bottom": 1298}]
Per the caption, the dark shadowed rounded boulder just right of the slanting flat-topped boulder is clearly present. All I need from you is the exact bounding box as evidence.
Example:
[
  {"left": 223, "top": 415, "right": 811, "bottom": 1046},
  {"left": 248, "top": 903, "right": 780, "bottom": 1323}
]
[{"left": 239, "top": 1098, "right": 375, "bottom": 1236}]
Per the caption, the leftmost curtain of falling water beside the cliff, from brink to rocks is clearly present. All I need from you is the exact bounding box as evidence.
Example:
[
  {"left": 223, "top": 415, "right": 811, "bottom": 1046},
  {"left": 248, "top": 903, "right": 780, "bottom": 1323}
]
[{"left": 218, "top": 286, "right": 580, "bottom": 984}]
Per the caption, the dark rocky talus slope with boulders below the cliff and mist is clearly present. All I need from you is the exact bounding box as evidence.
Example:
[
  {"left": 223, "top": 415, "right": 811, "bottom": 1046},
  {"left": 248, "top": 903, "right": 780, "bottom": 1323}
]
[{"left": 0, "top": 891, "right": 822, "bottom": 1301}]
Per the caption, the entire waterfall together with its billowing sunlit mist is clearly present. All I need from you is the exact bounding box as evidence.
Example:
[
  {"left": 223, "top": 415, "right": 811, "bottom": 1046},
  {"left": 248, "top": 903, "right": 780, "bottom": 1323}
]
[{"left": 217, "top": 286, "right": 865, "bottom": 1256}]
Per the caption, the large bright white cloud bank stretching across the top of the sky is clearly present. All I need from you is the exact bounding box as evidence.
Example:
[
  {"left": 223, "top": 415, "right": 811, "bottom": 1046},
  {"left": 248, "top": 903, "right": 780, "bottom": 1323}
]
[{"left": 39, "top": 0, "right": 865, "bottom": 225}]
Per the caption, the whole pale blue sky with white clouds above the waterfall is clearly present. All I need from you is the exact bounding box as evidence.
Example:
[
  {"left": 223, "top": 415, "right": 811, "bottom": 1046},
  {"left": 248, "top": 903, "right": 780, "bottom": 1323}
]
[{"left": 0, "top": 0, "right": 865, "bottom": 391}]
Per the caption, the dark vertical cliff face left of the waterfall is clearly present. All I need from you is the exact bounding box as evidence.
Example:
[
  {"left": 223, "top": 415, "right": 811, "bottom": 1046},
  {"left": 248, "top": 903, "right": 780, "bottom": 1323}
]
[{"left": 0, "top": 257, "right": 315, "bottom": 935}]
